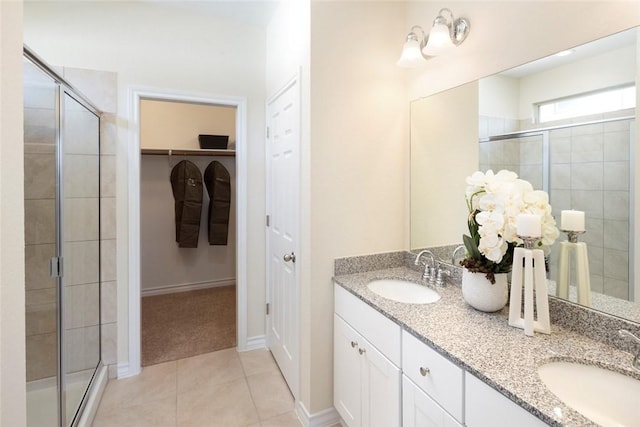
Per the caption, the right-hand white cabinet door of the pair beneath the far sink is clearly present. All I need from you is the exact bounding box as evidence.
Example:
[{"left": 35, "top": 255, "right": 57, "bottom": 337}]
[{"left": 359, "top": 341, "right": 401, "bottom": 427}]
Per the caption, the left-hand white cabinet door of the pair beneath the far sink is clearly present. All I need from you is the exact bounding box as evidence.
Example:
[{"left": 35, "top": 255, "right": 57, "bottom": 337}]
[{"left": 333, "top": 314, "right": 364, "bottom": 427}]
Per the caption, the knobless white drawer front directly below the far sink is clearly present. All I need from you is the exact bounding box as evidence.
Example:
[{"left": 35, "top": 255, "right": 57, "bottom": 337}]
[{"left": 334, "top": 284, "right": 402, "bottom": 366}]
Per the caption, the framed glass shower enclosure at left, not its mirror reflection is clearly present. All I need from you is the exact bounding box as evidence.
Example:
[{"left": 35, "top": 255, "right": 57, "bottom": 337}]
[{"left": 23, "top": 48, "right": 103, "bottom": 427}]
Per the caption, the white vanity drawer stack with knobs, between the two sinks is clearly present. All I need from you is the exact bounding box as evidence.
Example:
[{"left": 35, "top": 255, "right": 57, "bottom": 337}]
[{"left": 402, "top": 331, "right": 464, "bottom": 427}]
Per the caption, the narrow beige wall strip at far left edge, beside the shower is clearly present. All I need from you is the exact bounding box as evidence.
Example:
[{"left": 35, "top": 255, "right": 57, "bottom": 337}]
[{"left": 0, "top": 1, "right": 26, "bottom": 426}]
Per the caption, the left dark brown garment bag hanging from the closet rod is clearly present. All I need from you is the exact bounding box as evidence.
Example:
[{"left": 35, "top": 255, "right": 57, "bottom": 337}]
[{"left": 171, "top": 160, "right": 202, "bottom": 248}]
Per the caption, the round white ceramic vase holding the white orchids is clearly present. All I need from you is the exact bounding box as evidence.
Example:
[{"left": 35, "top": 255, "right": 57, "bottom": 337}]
[{"left": 462, "top": 268, "right": 509, "bottom": 313}]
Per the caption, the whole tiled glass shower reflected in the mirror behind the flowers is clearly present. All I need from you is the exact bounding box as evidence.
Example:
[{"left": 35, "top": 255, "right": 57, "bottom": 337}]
[{"left": 480, "top": 109, "right": 638, "bottom": 301}]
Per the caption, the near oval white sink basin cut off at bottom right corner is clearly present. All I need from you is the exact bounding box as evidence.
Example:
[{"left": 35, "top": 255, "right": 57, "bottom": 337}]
[{"left": 538, "top": 362, "right": 640, "bottom": 427}]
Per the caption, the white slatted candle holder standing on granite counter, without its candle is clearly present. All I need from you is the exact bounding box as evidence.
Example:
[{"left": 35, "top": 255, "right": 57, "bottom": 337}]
[{"left": 509, "top": 236, "right": 551, "bottom": 336}]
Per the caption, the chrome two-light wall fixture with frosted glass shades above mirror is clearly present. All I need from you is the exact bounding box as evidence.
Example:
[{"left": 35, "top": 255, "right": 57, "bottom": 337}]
[{"left": 397, "top": 8, "right": 469, "bottom": 68}]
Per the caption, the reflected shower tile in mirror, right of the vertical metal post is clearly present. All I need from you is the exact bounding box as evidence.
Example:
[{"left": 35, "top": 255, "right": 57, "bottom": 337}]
[{"left": 549, "top": 111, "right": 631, "bottom": 299}]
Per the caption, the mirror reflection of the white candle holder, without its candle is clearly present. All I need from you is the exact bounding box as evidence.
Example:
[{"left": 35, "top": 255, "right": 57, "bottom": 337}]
[{"left": 556, "top": 230, "right": 591, "bottom": 307}]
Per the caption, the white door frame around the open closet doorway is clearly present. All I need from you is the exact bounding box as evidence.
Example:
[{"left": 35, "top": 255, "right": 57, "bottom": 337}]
[{"left": 125, "top": 87, "right": 248, "bottom": 378}]
